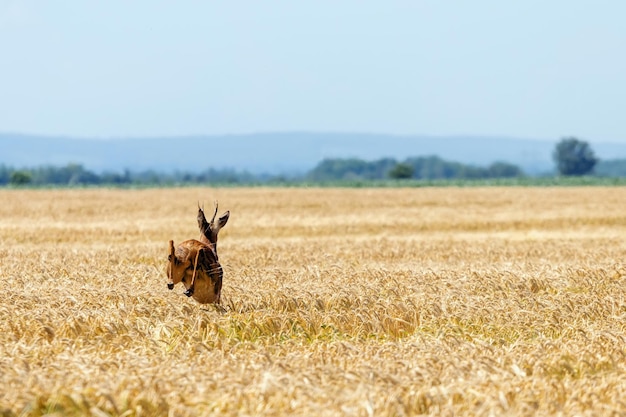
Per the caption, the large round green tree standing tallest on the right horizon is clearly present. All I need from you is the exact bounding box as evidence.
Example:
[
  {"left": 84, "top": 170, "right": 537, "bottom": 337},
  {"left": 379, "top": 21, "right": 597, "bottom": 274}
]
[{"left": 552, "top": 137, "right": 598, "bottom": 175}]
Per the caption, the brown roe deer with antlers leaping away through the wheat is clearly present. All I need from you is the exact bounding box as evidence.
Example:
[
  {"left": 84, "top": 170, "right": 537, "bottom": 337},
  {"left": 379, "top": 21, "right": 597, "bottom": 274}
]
[{"left": 167, "top": 203, "right": 230, "bottom": 304}]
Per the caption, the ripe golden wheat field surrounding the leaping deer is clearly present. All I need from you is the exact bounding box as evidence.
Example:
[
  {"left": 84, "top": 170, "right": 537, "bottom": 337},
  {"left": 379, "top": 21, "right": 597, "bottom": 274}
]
[{"left": 0, "top": 187, "right": 626, "bottom": 416}]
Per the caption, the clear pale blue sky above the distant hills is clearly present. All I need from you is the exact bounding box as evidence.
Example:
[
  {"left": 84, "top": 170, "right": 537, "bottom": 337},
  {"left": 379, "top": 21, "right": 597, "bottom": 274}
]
[{"left": 0, "top": 0, "right": 626, "bottom": 142}]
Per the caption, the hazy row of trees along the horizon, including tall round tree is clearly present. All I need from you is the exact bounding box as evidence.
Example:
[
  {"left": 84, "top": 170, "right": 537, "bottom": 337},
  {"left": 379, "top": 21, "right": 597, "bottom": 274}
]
[{"left": 0, "top": 137, "right": 626, "bottom": 186}]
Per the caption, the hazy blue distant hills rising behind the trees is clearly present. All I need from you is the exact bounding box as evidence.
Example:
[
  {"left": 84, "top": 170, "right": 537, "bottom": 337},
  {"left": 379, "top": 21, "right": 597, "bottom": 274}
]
[{"left": 0, "top": 132, "right": 626, "bottom": 174}]
